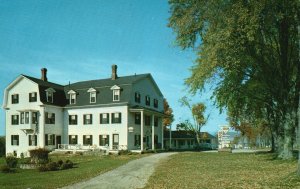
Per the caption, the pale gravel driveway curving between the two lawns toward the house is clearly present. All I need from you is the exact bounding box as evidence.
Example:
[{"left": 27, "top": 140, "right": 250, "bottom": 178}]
[{"left": 63, "top": 153, "right": 175, "bottom": 189}]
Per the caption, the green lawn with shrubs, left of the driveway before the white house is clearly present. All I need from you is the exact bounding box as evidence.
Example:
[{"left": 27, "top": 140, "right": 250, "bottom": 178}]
[{"left": 0, "top": 155, "right": 141, "bottom": 189}]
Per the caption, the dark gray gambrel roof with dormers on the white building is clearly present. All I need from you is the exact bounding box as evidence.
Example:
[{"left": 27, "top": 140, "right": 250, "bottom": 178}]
[{"left": 23, "top": 74, "right": 152, "bottom": 107}]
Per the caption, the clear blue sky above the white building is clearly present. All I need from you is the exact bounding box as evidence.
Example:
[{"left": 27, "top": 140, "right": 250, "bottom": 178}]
[{"left": 0, "top": 0, "right": 227, "bottom": 135}]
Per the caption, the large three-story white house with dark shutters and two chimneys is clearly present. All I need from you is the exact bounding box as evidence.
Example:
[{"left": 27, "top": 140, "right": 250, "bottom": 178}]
[{"left": 3, "top": 65, "right": 164, "bottom": 156}]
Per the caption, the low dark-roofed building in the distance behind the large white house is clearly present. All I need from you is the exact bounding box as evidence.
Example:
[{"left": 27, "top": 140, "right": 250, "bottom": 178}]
[{"left": 164, "top": 131, "right": 217, "bottom": 149}]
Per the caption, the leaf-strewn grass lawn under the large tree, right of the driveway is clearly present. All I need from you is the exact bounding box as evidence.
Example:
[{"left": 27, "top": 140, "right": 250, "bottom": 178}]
[{"left": 146, "top": 152, "right": 300, "bottom": 189}]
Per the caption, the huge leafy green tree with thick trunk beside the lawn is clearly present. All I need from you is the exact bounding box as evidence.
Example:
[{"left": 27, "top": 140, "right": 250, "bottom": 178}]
[{"left": 169, "top": 0, "right": 300, "bottom": 159}]
